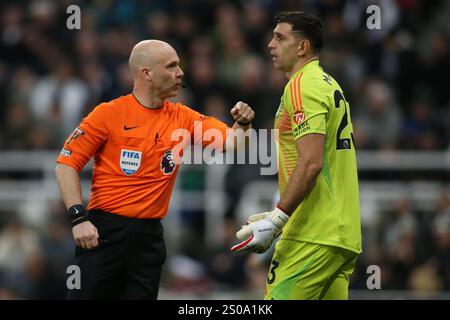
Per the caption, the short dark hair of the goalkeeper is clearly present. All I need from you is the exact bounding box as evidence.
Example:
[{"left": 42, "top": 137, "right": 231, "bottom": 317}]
[{"left": 274, "top": 11, "right": 323, "bottom": 53}]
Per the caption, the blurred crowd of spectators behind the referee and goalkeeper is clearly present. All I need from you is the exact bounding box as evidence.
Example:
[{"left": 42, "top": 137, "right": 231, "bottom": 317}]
[{"left": 0, "top": 0, "right": 450, "bottom": 299}]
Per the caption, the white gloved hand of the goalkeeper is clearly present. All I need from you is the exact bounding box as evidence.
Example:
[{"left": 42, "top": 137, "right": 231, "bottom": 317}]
[{"left": 231, "top": 208, "right": 289, "bottom": 253}]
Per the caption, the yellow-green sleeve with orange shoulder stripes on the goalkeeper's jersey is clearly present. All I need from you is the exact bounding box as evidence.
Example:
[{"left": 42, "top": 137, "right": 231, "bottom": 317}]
[{"left": 284, "top": 73, "right": 328, "bottom": 140}]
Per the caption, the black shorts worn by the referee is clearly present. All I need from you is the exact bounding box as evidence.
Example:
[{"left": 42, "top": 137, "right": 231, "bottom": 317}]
[{"left": 67, "top": 210, "right": 166, "bottom": 299}]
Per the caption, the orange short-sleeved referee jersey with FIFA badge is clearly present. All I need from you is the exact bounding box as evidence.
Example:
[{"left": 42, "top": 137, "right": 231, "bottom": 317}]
[{"left": 56, "top": 94, "right": 228, "bottom": 219}]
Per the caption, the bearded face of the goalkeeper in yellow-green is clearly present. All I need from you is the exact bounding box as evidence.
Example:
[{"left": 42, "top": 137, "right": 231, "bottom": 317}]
[{"left": 268, "top": 22, "right": 298, "bottom": 72}]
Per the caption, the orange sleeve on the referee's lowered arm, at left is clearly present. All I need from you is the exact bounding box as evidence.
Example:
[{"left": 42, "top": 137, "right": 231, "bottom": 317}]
[{"left": 56, "top": 104, "right": 108, "bottom": 172}]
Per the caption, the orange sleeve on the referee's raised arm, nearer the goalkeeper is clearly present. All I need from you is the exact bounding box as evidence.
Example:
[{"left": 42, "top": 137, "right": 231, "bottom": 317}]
[{"left": 180, "top": 107, "right": 229, "bottom": 150}]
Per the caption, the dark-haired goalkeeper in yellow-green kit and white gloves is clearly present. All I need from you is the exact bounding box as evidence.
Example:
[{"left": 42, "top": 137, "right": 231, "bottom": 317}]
[{"left": 231, "top": 11, "right": 361, "bottom": 300}]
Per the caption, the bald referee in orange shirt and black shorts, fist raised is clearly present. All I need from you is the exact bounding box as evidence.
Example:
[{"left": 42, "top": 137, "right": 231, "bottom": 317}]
[{"left": 56, "top": 40, "right": 255, "bottom": 299}]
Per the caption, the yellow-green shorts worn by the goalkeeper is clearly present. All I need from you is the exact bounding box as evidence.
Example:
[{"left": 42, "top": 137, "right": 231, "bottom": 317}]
[{"left": 264, "top": 239, "right": 359, "bottom": 300}]
